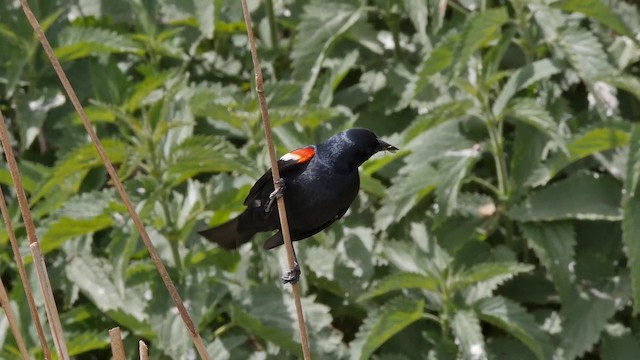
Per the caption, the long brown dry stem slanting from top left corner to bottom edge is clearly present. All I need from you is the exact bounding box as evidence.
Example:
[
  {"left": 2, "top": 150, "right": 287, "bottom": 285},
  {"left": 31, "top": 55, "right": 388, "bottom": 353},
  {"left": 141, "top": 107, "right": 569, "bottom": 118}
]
[{"left": 20, "top": 0, "right": 209, "bottom": 360}]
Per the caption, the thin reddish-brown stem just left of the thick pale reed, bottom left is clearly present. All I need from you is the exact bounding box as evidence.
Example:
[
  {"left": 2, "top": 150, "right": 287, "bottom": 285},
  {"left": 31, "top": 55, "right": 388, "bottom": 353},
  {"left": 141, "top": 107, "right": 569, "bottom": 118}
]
[{"left": 0, "top": 178, "right": 51, "bottom": 360}]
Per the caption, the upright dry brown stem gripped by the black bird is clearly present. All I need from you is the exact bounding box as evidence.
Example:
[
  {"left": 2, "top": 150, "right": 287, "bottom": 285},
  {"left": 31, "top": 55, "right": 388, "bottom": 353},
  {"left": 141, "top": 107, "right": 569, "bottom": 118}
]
[{"left": 241, "top": 0, "right": 311, "bottom": 360}]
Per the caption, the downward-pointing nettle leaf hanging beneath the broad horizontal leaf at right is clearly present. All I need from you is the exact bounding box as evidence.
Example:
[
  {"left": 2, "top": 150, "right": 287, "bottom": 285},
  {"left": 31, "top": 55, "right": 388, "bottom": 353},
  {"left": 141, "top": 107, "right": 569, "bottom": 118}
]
[{"left": 520, "top": 222, "right": 576, "bottom": 304}]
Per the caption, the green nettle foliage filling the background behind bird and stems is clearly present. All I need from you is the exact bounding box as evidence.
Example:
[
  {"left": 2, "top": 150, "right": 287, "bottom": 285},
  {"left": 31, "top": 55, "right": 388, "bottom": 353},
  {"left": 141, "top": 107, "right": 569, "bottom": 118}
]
[{"left": 0, "top": 0, "right": 640, "bottom": 360}]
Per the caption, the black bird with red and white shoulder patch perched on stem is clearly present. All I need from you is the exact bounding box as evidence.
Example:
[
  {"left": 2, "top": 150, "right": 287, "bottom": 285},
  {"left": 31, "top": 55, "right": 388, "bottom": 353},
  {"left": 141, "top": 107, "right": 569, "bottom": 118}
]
[{"left": 199, "top": 128, "right": 398, "bottom": 282}]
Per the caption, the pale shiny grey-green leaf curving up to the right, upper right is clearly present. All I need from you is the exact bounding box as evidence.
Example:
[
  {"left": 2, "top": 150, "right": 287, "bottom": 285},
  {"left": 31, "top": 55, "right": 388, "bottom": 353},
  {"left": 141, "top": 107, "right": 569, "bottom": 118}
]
[{"left": 491, "top": 59, "right": 564, "bottom": 116}]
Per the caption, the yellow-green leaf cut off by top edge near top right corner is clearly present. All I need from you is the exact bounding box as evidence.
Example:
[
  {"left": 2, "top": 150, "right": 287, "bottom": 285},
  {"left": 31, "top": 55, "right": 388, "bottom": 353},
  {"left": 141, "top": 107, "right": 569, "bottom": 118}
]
[{"left": 551, "top": 0, "right": 634, "bottom": 38}]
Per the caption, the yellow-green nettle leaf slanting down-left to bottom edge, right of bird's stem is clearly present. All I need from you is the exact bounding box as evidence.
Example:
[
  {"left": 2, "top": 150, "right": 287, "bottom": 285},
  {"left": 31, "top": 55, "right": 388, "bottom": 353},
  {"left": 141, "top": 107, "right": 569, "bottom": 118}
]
[{"left": 350, "top": 296, "right": 424, "bottom": 360}]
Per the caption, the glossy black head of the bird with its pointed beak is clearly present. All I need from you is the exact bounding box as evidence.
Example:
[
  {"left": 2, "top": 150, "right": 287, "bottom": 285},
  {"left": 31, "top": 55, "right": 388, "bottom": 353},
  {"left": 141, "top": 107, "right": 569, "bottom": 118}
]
[{"left": 324, "top": 128, "right": 398, "bottom": 171}]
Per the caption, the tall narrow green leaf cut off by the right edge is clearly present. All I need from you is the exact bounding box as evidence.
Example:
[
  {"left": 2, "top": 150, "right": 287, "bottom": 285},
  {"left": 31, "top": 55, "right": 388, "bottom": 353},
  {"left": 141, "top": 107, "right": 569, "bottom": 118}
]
[{"left": 622, "top": 126, "right": 640, "bottom": 314}]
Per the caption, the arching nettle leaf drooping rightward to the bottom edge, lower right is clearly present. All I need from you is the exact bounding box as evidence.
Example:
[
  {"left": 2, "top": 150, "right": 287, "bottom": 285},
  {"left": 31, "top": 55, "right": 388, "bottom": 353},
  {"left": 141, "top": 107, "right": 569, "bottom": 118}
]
[{"left": 475, "top": 296, "right": 553, "bottom": 360}]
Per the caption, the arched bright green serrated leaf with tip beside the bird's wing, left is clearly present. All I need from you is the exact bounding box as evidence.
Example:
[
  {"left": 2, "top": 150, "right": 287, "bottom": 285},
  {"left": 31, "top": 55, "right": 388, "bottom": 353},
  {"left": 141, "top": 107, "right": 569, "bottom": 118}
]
[{"left": 167, "top": 135, "right": 256, "bottom": 185}]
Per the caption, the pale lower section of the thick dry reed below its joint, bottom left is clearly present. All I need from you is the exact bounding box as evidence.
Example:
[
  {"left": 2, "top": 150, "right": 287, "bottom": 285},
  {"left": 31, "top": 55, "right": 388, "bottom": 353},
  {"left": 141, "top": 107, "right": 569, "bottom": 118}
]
[{"left": 27, "top": 243, "right": 69, "bottom": 360}]
